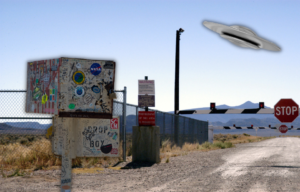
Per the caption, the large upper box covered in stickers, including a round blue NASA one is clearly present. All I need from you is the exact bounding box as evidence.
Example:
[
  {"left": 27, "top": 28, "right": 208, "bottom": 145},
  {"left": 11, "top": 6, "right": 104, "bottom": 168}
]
[{"left": 26, "top": 57, "right": 116, "bottom": 119}]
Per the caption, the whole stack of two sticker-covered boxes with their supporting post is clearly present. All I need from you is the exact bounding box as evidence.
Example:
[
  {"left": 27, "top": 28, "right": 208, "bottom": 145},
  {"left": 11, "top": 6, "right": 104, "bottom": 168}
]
[{"left": 25, "top": 57, "right": 120, "bottom": 192}]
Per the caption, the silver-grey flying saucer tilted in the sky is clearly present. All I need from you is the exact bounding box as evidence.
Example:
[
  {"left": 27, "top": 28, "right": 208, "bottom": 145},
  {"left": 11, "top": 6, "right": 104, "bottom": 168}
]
[{"left": 203, "top": 21, "right": 281, "bottom": 51}]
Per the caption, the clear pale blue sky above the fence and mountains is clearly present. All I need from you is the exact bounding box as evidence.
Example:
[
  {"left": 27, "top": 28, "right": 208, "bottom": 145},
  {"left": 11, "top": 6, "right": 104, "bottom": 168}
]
[{"left": 0, "top": 0, "right": 300, "bottom": 111}]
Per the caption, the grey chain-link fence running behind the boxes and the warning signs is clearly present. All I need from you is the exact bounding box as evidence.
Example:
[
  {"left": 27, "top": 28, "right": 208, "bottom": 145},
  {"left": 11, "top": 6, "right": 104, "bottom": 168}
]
[{"left": 0, "top": 87, "right": 208, "bottom": 171}]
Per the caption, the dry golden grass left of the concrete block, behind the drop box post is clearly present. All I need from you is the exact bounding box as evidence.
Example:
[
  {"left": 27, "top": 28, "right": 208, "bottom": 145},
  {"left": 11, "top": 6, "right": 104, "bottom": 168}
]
[{"left": 0, "top": 136, "right": 124, "bottom": 177}]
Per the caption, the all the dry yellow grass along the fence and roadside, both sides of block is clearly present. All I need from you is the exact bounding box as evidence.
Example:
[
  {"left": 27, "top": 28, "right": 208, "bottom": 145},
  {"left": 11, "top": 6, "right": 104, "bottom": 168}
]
[{"left": 0, "top": 134, "right": 274, "bottom": 177}]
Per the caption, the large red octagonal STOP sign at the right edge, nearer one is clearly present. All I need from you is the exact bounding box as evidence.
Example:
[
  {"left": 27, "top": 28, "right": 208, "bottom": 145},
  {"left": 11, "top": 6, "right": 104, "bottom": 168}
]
[{"left": 274, "top": 99, "right": 299, "bottom": 123}]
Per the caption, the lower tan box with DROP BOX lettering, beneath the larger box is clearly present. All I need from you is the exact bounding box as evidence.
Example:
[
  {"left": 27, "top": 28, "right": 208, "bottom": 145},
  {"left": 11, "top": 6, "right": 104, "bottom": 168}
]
[{"left": 51, "top": 116, "right": 120, "bottom": 158}]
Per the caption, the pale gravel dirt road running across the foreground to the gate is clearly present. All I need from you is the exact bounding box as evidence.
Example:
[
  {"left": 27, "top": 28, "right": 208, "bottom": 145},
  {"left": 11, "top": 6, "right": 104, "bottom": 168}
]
[{"left": 0, "top": 138, "right": 300, "bottom": 192}]
